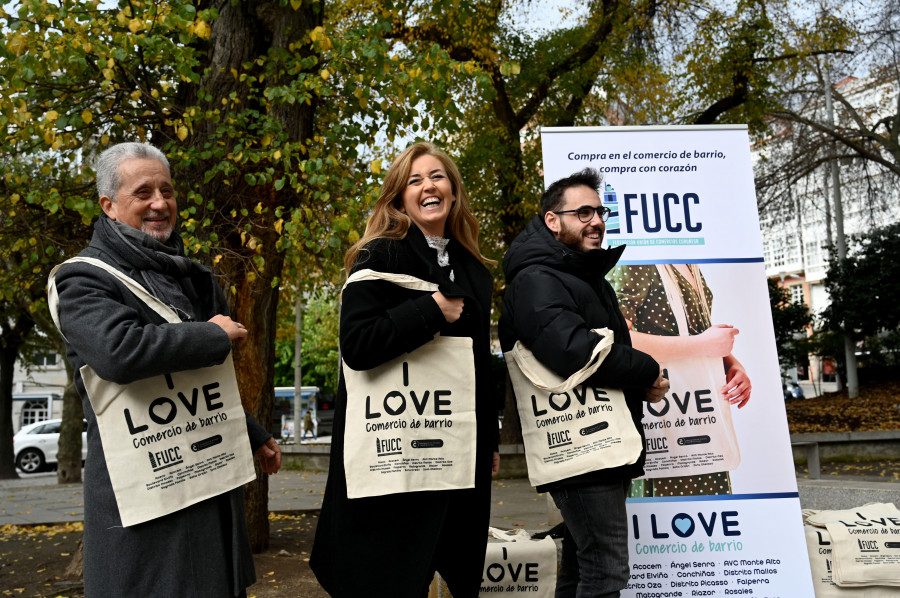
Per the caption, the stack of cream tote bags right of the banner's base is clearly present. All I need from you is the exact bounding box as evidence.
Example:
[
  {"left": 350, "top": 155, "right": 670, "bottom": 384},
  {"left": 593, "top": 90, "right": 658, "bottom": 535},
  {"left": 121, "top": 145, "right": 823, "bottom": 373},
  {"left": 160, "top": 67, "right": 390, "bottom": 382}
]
[{"left": 803, "top": 503, "right": 900, "bottom": 598}]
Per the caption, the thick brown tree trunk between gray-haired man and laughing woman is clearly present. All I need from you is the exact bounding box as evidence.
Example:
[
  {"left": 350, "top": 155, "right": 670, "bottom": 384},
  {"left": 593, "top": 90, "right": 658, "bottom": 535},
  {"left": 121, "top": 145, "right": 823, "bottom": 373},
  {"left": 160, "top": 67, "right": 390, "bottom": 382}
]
[{"left": 184, "top": 0, "right": 322, "bottom": 552}]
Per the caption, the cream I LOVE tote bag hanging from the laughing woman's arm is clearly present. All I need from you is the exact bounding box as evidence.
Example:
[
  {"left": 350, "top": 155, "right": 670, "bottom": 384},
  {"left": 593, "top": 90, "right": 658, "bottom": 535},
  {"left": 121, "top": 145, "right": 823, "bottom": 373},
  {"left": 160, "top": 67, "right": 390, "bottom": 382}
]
[{"left": 341, "top": 270, "right": 476, "bottom": 498}]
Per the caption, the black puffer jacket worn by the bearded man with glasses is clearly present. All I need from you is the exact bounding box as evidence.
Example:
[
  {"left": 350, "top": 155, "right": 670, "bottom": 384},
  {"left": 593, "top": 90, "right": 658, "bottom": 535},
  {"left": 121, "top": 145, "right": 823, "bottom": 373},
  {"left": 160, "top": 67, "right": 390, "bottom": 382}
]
[{"left": 499, "top": 216, "right": 659, "bottom": 492}]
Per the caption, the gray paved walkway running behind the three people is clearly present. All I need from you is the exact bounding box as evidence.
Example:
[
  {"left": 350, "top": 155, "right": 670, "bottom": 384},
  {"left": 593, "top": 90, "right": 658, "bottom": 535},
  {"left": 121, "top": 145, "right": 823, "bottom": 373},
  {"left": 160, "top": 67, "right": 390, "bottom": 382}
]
[{"left": 0, "top": 470, "right": 900, "bottom": 531}]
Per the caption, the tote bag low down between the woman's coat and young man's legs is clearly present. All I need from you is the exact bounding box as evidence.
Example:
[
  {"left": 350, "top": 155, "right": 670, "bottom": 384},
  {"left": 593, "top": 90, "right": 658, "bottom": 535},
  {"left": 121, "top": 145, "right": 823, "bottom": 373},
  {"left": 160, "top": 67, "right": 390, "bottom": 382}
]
[{"left": 478, "top": 527, "right": 558, "bottom": 598}]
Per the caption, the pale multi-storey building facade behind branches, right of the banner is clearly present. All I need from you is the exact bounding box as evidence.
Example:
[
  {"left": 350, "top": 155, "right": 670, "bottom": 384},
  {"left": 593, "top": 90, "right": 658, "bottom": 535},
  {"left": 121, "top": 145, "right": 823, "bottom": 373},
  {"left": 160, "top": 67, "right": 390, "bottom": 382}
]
[{"left": 753, "top": 72, "right": 900, "bottom": 382}]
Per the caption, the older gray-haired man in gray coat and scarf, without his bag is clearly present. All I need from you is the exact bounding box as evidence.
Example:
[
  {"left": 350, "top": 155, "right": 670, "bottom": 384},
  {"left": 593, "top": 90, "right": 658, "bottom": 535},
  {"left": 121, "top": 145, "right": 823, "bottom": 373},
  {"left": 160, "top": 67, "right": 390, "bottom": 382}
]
[{"left": 55, "top": 143, "right": 281, "bottom": 597}]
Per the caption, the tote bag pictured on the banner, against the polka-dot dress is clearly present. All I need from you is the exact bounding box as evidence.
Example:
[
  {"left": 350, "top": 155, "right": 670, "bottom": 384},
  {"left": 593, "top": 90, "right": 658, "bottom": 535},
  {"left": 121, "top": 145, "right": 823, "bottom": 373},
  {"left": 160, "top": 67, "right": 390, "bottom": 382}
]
[{"left": 643, "top": 264, "right": 741, "bottom": 478}]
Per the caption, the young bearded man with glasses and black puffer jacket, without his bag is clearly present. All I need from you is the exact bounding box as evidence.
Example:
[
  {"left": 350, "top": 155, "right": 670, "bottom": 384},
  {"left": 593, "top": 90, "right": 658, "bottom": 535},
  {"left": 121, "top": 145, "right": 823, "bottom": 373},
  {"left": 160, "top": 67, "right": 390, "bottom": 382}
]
[{"left": 500, "top": 169, "right": 668, "bottom": 598}]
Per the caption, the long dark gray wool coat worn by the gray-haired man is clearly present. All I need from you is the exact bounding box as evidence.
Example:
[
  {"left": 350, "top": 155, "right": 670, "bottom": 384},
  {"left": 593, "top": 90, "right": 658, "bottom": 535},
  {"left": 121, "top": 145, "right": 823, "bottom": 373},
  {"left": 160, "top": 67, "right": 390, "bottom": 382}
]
[{"left": 56, "top": 226, "right": 270, "bottom": 598}]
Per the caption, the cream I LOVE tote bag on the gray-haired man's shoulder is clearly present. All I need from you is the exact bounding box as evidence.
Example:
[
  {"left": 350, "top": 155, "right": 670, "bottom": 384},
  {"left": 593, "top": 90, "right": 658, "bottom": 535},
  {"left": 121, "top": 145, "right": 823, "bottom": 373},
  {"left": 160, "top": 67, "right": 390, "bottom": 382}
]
[{"left": 47, "top": 257, "right": 256, "bottom": 527}]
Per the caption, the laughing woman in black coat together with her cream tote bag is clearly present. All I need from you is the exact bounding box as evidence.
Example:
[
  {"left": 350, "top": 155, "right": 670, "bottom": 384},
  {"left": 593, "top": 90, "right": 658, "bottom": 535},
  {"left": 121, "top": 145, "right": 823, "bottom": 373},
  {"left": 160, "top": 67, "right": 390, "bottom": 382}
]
[{"left": 310, "top": 142, "right": 499, "bottom": 598}]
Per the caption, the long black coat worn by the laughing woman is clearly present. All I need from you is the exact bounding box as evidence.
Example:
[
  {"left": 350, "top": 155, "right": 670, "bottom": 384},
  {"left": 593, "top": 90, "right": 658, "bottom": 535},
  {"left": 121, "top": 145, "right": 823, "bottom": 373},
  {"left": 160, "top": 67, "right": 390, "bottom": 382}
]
[{"left": 310, "top": 226, "right": 498, "bottom": 598}]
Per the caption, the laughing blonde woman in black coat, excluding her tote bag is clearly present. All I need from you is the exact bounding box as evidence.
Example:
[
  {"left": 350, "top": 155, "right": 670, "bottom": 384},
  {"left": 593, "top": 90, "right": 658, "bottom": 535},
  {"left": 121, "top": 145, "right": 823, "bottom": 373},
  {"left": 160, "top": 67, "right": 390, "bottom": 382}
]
[{"left": 310, "top": 143, "right": 499, "bottom": 598}]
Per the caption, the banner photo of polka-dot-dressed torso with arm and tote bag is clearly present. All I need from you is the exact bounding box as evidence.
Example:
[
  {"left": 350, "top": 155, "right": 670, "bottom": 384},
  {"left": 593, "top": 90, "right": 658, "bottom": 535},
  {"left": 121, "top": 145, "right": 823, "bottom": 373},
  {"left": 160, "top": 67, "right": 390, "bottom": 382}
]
[{"left": 609, "top": 264, "right": 751, "bottom": 496}]
